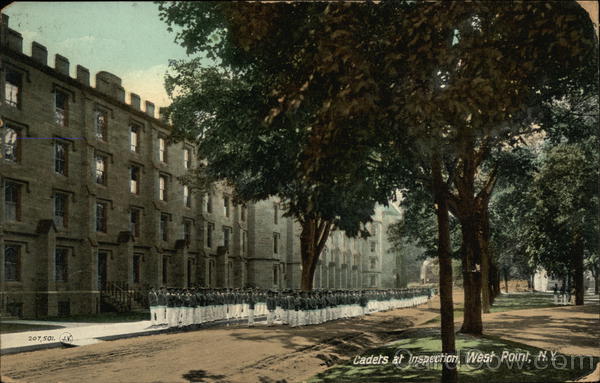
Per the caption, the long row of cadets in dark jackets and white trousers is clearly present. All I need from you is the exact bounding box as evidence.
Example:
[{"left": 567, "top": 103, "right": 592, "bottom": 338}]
[{"left": 148, "top": 287, "right": 435, "bottom": 328}]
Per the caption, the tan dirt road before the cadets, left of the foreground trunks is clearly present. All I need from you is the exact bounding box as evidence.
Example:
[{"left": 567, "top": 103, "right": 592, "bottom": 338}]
[{"left": 2, "top": 301, "right": 437, "bottom": 383}]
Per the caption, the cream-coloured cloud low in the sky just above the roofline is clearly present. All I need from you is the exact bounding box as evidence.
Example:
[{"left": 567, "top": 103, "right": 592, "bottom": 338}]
[{"left": 120, "top": 64, "right": 170, "bottom": 108}]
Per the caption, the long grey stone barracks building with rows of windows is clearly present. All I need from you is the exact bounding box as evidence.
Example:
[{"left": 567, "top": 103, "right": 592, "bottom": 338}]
[{"left": 0, "top": 15, "right": 400, "bottom": 318}]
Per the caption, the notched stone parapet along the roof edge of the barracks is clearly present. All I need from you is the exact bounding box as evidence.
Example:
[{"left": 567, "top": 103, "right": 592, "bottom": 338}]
[{"left": 0, "top": 14, "right": 160, "bottom": 121}]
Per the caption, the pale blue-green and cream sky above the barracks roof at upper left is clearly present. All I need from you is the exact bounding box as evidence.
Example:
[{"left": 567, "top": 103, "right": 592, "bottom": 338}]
[{"left": 2, "top": 1, "right": 187, "bottom": 107}]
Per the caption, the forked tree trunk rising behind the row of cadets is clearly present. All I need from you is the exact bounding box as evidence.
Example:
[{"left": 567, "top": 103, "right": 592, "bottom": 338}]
[{"left": 300, "top": 218, "right": 331, "bottom": 291}]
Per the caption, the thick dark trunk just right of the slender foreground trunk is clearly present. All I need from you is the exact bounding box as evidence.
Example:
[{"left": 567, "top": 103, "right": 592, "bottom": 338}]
[{"left": 460, "top": 216, "right": 483, "bottom": 335}]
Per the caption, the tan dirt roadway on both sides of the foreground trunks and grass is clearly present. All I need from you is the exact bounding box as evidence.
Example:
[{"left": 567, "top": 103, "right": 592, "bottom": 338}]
[{"left": 1, "top": 291, "right": 600, "bottom": 383}]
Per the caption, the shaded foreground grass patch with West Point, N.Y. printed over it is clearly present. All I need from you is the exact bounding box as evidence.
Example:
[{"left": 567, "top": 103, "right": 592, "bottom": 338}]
[{"left": 309, "top": 328, "right": 600, "bottom": 383}]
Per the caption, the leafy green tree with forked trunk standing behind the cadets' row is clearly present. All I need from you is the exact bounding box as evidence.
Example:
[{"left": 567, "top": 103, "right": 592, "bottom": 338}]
[{"left": 161, "top": 3, "right": 392, "bottom": 290}]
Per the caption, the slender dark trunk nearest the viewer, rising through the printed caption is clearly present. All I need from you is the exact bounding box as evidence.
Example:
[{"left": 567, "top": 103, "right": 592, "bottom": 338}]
[{"left": 431, "top": 157, "right": 458, "bottom": 383}]
